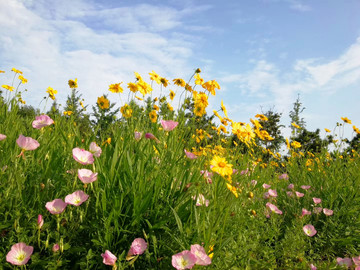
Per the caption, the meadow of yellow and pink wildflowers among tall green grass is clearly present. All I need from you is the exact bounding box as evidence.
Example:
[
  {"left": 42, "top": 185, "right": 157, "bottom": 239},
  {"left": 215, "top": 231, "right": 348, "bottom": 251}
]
[{"left": 0, "top": 68, "right": 360, "bottom": 270}]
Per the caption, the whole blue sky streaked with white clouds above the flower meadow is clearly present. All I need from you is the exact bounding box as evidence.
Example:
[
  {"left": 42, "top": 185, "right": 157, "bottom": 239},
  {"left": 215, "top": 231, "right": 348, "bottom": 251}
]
[{"left": 0, "top": 0, "right": 360, "bottom": 137}]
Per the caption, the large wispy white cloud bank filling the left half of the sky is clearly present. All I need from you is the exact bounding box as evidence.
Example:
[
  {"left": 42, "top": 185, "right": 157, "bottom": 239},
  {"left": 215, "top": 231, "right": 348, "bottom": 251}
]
[{"left": 0, "top": 0, "right": 210, "bottom": 107}]
